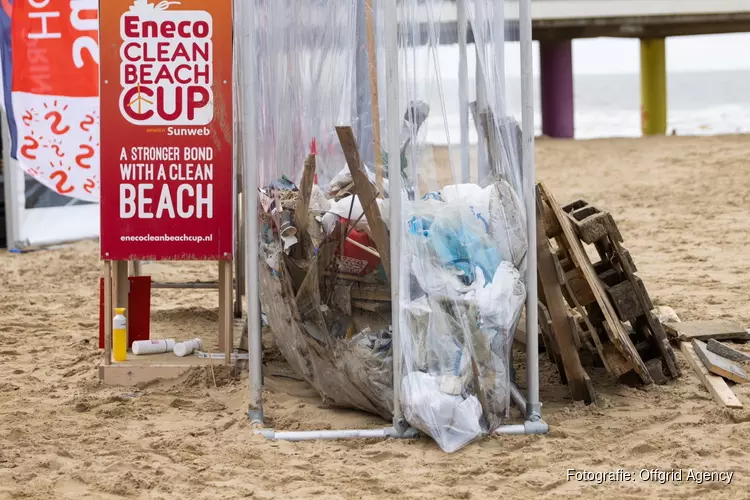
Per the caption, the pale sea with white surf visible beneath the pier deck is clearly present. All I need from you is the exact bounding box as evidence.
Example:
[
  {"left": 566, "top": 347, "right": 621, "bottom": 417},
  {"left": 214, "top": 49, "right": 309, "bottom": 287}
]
[{"left": 425, "top": 70, "right": 750, "bottom": 144}]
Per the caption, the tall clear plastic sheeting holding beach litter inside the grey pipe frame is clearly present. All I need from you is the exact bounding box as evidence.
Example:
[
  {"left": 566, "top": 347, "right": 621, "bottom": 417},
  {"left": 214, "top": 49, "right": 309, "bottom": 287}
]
[{"left": 247, "top": 0, "right": 528, "bottom": 452}]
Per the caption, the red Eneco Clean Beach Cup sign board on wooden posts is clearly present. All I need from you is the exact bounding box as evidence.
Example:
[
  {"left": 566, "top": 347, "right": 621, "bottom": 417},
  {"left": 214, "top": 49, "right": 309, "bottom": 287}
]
[{"left": 99, "top": 0, "right": 233, "bottom": 260}]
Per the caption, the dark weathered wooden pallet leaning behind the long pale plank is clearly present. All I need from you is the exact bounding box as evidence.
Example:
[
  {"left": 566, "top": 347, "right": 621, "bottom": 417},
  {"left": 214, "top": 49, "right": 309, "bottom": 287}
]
[{"left": 563, "top": 200, "right": 680, "bottom": 377}]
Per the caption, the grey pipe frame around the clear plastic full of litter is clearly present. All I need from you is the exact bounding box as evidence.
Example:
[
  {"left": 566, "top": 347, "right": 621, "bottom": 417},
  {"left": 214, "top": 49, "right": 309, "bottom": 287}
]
[{"left": 247, "top": 0, "right": 549, "bottom": 441}]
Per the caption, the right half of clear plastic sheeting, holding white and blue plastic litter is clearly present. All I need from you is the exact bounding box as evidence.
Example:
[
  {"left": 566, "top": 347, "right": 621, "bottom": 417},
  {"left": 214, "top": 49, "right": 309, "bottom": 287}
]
[{"left": 400, "top": 0, "right": 528, "bottom": 452}]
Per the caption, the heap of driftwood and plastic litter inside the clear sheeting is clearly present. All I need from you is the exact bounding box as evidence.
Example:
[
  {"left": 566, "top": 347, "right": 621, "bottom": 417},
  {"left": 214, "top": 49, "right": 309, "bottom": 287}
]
[{"left": 259, "top": 128, "right": 528, "bottom": 452}]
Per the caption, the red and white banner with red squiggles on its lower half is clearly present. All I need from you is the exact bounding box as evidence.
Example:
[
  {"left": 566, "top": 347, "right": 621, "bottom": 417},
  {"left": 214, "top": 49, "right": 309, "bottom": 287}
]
[{"left": 10, "top": 0, "right": 99, "bottom": 201}]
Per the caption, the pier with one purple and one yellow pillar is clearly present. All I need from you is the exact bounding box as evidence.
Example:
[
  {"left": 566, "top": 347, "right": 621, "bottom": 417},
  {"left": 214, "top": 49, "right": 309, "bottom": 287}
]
[{"left": 408, "top": 0, "right": 750, "bottom": 138}]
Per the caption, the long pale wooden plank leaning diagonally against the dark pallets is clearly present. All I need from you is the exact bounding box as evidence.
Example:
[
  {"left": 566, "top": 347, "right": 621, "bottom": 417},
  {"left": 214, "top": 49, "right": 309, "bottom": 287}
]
[{"left": 538, "top": 183, "right": 653, "bottom": 384}]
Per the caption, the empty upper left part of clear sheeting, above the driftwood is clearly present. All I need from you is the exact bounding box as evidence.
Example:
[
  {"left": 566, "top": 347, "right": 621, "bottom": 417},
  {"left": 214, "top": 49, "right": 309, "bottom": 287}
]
[{"left": 250, "top": 0, "right": 358, "bottom": 186}]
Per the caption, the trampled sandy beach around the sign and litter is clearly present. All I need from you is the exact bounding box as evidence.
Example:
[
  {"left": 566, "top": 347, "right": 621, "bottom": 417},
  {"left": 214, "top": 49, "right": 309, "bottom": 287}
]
[{"left": 0, "top": 136, "right": 750, "bottom": 500}]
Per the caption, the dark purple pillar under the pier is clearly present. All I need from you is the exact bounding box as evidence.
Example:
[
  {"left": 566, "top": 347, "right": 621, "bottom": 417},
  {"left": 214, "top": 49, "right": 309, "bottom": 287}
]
[{"left": 539, "top": 40, "right": 575, "bottom": 138}]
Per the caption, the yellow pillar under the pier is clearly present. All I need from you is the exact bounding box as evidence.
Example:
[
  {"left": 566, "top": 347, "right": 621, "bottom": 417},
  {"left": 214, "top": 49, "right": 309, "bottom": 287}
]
[{"left": 641, "top": 38, "right": 667, "bottom": 135}]
